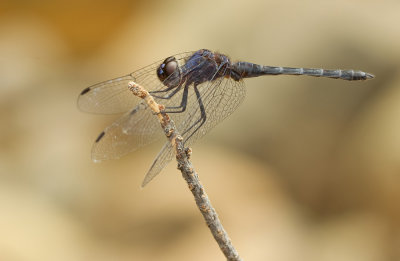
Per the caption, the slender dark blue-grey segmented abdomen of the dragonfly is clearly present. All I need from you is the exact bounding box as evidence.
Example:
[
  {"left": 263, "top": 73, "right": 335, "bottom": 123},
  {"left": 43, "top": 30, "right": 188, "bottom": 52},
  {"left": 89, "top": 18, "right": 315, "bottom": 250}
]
[{"left": 233, "top": 62, "right": 374, "bottom": 81}]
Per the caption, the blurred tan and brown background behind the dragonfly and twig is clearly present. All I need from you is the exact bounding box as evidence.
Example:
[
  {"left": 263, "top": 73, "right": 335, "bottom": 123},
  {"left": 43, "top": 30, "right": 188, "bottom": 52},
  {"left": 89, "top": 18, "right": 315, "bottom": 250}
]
[{"left": 0, "top": 0, "right": 400, "bottom": 261}]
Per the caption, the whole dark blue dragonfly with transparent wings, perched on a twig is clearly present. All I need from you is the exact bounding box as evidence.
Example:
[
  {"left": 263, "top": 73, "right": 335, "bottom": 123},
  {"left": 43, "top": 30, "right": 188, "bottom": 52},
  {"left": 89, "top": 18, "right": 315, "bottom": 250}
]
[{"left": 78, "top": 49, "right": 374, "bottom": 187}]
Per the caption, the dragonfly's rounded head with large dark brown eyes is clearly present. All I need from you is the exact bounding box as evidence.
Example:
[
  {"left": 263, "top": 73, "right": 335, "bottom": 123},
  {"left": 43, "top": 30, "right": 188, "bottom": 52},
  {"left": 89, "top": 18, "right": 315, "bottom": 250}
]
[{"left": 157, "top": 56, "right": 181, "bottom": 87}]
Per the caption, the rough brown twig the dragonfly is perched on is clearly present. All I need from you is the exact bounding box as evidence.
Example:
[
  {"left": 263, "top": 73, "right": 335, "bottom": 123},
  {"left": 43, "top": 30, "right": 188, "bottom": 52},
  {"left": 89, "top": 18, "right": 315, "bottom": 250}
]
[{"left": 128, "top": 81, "right": 242, "bottom": 261}]
